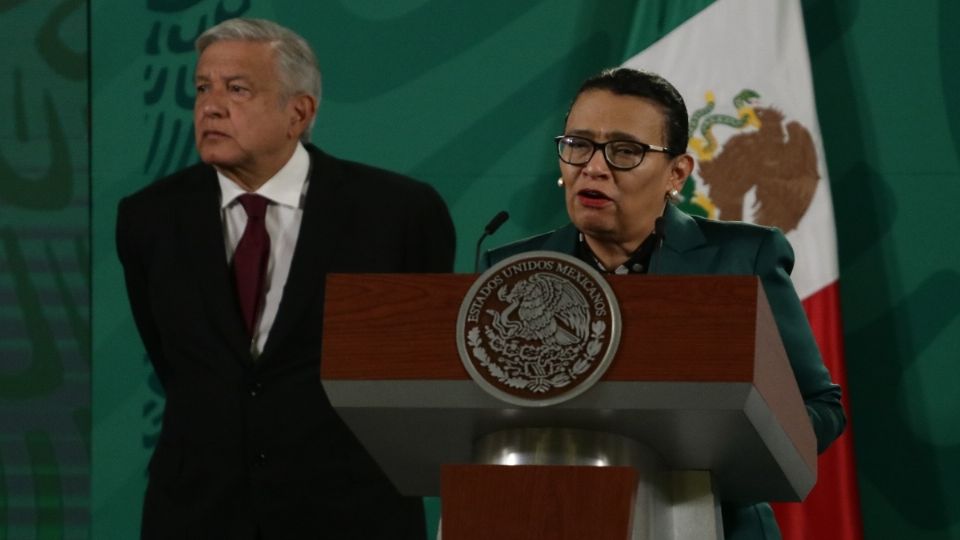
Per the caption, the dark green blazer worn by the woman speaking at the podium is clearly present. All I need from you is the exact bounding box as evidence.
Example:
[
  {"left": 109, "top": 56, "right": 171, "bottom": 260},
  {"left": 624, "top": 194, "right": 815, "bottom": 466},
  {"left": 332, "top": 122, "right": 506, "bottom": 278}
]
[{"left": 481, "top": 204, "right": 846, "bottom": 540}]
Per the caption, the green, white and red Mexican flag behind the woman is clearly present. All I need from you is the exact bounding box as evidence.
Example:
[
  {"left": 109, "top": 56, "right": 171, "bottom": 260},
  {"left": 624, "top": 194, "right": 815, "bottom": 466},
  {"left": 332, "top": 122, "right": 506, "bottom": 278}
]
[{"left": 624, "top": 0, "right": 863, "bottom": 540}]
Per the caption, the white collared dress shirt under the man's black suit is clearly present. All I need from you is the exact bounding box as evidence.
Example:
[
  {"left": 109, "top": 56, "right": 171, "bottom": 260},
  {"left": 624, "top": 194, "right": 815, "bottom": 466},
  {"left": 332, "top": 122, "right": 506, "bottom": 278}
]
[{"left": 217, "top": 144, "right": 310, "bottom": 358}]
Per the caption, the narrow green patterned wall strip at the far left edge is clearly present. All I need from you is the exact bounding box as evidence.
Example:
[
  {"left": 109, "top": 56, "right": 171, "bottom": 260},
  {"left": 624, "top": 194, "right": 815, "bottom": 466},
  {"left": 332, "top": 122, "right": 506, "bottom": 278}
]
[{"left": 0, "top": 0, "right": 90, "bottom": 539}]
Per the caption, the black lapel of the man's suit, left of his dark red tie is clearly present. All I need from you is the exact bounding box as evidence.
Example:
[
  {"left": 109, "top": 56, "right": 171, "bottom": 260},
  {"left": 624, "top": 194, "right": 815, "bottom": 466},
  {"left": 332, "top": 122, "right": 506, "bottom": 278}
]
[{"left": 179, "top": 166, "right": 250, "bottom": 359}]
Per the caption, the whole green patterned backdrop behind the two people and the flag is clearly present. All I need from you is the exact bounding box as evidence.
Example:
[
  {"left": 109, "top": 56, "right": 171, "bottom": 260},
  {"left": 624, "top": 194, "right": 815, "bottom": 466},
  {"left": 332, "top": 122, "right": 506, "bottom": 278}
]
[{"left": 0, "top": 0, "right": 960, "bottom": 540}]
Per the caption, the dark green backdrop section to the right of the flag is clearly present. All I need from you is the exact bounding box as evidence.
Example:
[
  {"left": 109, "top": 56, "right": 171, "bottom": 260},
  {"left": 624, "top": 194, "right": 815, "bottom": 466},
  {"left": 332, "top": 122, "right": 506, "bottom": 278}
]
[{"left": 806, "top": 0, "right": 960, "bottom": 539}]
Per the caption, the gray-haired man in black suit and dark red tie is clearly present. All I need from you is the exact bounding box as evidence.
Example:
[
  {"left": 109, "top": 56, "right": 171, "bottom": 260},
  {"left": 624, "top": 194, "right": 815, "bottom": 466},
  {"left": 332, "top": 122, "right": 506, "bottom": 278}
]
[{"left": 117, "top": 19, "right": 455, "bottom": 539}]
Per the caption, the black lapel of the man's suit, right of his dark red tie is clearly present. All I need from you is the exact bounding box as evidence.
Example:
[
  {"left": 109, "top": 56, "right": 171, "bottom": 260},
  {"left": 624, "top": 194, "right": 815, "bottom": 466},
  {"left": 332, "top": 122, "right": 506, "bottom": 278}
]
[{"left": 260, "top": 145, "right": 346, "bottom": 364}]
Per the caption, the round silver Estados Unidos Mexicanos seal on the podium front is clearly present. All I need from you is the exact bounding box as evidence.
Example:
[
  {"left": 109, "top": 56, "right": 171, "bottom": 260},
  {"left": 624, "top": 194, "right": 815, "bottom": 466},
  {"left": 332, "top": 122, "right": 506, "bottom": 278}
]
[{"left": 457, "top": 251, "right": 621, "bottom": 406}]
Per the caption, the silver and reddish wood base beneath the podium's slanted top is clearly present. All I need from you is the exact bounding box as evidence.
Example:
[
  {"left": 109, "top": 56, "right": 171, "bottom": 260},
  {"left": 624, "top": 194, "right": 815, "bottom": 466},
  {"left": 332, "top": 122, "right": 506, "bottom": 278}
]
[{"left": 438, "top": 429, "right": 723, "bottom": 540}]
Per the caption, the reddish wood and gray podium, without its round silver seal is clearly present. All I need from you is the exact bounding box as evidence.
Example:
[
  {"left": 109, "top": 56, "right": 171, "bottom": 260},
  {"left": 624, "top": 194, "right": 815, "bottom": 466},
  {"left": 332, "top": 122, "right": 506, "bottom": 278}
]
[{"left": 321, "top": 274, "right": 816, "bottom": 540}]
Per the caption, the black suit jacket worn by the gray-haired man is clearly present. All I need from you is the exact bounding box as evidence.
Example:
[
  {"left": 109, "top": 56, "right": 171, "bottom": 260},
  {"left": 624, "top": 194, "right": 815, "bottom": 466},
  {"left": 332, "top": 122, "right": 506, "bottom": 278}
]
[{"left": 116, "top": 141, "right": 455, "bottom": 539}]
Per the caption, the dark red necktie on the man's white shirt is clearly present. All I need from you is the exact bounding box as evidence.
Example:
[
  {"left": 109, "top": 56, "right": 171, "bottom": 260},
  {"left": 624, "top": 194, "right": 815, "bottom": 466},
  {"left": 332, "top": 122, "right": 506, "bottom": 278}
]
[{"left": 233, "top": 193, "right": 270, "bottom": 336}]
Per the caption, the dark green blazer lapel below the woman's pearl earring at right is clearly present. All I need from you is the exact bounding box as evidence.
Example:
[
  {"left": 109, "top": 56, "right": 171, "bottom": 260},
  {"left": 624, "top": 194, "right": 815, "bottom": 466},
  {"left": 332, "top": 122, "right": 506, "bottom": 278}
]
[{"left": 650, "top": 204, "right": 717, "bottom": 274}]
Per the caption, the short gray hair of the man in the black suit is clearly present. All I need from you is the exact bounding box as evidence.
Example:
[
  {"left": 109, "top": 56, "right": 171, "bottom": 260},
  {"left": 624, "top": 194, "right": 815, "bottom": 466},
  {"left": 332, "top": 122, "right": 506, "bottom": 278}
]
[{"left": 195, "top": 18, "right": 320, "bottom": 142}]
